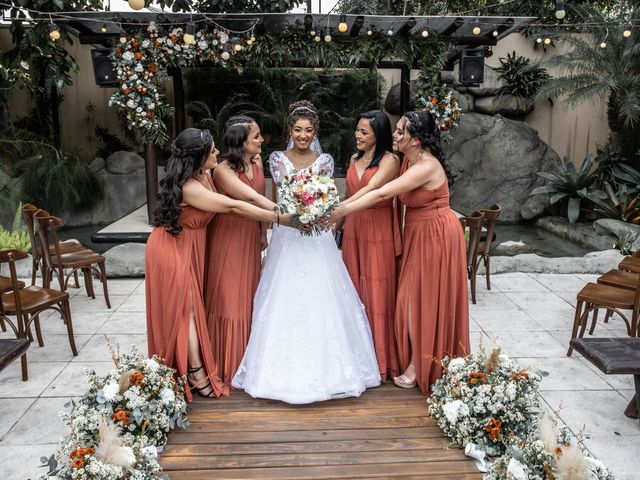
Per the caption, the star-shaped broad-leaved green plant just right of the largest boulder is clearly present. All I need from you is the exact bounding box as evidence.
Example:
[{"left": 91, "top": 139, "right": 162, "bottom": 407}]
[{"left": 529, "top": 155, "right": 598, "bottom": 223}]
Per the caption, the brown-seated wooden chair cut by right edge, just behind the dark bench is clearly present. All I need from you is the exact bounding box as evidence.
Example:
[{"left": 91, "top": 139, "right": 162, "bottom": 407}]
[{"left": 567, "top": 275, "right": 640, "bottom": 357}]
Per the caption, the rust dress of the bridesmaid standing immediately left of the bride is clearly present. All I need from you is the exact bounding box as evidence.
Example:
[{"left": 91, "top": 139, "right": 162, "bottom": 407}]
[{"left": 204, "top": 164, "right": 265, "bottom": 388}]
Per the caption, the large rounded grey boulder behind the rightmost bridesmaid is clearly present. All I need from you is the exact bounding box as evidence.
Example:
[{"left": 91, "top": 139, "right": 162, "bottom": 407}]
[{"left": 446, "top": 113, "right": 558, "bottom": 222}]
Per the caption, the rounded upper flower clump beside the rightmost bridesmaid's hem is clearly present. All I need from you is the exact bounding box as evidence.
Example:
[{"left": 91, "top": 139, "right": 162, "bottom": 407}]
[{"left": 429, "top": 348, "right": 541, "bottom": 455}]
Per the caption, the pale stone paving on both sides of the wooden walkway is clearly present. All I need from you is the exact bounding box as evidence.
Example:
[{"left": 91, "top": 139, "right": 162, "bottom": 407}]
[{"left": 0, "top": 273, "right": 640, "bottom": 480}]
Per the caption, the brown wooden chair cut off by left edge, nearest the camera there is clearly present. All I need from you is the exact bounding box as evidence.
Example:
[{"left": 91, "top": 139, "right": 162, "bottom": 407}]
[{"left": 0, "top": 250, "right": 78, "bottom": 380}]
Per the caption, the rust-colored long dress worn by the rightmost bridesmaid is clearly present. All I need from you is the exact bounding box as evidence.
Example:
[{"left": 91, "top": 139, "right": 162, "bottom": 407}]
[{"left": 395, "top": 158, "right": 470, "bottom": 394}]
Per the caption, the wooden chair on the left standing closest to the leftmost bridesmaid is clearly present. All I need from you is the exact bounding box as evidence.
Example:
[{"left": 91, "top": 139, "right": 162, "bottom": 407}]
[{"left": 35, "top": 213, "right": 111, "bottom": 308}]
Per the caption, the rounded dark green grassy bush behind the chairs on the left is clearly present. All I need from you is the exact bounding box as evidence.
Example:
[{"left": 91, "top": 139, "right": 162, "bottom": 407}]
[{"left": 19, "top": 149, "right": 103, "bottom": 214}]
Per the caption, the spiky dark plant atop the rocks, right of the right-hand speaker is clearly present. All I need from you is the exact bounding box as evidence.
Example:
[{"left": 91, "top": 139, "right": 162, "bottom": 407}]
[{"left": 496, "top": 51, "right": 549, "bottom": 98}]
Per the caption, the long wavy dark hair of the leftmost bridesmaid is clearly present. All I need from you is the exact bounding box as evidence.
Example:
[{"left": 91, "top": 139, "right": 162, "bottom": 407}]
[{"left": 153, "top": 128, "right": 213, "bottom": 236}]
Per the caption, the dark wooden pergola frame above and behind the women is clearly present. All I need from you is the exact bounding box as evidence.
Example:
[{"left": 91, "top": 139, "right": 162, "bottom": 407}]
[{"left": 61, "top": 12, "right": 535, "bottom": 219}]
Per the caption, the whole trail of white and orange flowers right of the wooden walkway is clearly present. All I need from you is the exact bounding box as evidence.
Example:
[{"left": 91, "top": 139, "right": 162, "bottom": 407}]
[{"left": 428, "top": 347, "right": 613, "bottom": 480}]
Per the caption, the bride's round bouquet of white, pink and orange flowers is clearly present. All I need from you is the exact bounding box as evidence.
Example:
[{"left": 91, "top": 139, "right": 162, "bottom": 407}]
[{"left": 278, "top": 168, "right": 340, "bottom": 235}]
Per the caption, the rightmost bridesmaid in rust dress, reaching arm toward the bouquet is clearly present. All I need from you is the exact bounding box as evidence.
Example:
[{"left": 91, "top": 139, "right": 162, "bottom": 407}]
[{"left": 330, "top": 112, "right": 469, "bottom": 394}]
